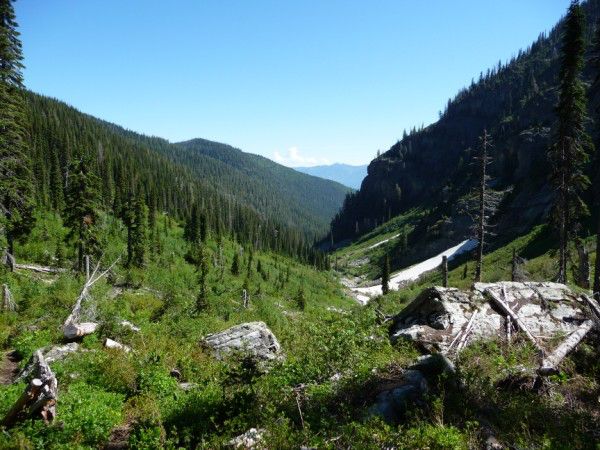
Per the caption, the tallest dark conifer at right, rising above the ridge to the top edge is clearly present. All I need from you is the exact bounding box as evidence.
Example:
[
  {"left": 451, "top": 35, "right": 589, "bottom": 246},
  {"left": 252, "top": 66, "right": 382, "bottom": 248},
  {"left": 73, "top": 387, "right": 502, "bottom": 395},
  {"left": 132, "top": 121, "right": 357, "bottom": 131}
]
[{"left": 548, "top": 0, "right": 591, "bottom": 283}]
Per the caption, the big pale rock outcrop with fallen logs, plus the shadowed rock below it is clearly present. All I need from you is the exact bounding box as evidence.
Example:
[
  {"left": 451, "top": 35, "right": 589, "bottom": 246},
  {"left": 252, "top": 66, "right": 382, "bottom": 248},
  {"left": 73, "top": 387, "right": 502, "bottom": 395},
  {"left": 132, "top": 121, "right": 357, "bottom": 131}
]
[{"left": 369, "top": 282, "right": 600, "bottom": 426}]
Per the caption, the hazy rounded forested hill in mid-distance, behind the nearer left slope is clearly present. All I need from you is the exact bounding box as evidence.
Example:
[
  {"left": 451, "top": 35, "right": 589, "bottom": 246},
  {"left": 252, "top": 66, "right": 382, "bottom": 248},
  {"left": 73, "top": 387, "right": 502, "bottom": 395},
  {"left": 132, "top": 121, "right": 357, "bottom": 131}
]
[{"left": 167, "top": 139, "right": 348, "bottom": 235}]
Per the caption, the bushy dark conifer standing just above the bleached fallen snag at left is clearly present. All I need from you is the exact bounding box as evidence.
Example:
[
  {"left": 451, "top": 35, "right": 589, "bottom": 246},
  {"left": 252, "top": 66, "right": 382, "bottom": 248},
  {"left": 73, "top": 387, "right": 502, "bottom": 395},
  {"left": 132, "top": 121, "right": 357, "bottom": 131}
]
[{"left": 64, "top": 155, "right": 100, "bottom": 272}]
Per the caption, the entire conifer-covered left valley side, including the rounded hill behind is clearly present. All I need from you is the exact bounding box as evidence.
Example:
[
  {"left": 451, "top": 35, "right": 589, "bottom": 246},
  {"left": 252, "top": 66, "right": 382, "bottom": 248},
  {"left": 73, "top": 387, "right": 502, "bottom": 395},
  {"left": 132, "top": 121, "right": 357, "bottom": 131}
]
[{"left": 28, "top": 93, "right": 348, "bottom": 246}]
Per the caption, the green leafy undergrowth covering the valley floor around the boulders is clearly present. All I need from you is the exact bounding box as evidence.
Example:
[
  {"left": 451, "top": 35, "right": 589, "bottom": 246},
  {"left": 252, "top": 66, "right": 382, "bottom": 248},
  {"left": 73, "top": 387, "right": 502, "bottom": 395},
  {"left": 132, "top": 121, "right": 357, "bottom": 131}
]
[{"left": 0, "top": 215, "right": 600, "bottom": 449}]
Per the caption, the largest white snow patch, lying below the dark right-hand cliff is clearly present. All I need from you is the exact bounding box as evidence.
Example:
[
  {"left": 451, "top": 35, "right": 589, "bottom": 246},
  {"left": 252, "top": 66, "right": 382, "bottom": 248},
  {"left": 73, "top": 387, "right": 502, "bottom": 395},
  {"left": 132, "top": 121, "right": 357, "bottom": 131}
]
[{"left": 352, "top": 239, "right": 477, "bottom": 305}]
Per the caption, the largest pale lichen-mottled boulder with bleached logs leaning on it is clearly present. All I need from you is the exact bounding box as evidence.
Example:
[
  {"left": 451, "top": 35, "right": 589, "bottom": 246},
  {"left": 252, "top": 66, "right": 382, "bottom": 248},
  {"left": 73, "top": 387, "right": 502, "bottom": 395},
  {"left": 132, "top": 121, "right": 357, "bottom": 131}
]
[{"left": 390, "top": 282, "right": 585, "bottom": 354}]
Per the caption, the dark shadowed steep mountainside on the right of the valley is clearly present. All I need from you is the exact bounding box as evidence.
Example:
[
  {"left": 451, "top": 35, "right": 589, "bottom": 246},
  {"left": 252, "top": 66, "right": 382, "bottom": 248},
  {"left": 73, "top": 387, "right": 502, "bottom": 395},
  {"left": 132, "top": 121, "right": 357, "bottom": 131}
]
[{"left": 332, "top": 0, "right": 600, "bottom": 265}]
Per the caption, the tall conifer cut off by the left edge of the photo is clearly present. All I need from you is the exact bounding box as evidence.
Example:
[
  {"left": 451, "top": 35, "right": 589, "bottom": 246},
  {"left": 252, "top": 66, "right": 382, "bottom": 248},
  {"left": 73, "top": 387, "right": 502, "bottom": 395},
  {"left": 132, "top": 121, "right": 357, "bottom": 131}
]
[{"left": 0, "top": 0, "right": 34, "bottom": 254}]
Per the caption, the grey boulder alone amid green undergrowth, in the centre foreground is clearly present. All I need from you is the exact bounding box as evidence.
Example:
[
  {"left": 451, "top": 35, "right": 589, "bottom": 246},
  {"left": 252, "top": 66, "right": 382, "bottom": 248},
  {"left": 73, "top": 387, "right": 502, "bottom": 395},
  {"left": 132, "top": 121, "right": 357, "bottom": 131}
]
[{"left": 202, "top": 322, "right": 281, "bottom": 361}]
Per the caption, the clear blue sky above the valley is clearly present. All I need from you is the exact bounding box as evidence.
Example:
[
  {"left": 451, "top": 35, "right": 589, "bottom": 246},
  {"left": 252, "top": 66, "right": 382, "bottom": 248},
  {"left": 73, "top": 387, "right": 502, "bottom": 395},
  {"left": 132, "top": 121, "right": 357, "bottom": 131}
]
[{"left": 15, "top": 0, "right": 569, "bottom": 165}]
